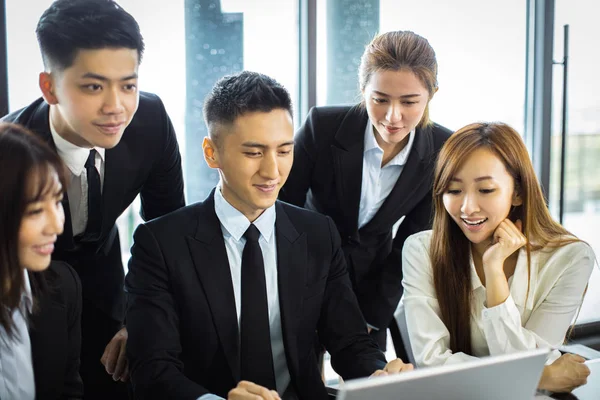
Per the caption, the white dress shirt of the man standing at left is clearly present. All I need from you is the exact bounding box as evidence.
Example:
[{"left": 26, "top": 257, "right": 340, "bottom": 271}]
[{"left": 50, "top": 121, "right": 106, "bottom": 236}]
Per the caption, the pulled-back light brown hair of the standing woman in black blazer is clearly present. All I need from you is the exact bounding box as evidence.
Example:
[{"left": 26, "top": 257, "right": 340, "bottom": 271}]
[{"left": 358, "top": 31, "right": 438, "bottom": 127}]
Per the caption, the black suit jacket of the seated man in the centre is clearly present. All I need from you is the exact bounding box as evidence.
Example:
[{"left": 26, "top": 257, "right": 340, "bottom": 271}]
[{"left": 125, "top": 191, "right": 385, "bottom": 400}]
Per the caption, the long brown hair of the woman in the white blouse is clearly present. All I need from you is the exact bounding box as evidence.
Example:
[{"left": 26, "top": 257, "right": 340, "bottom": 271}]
[{"left": 430, "top": 123, "right": 578, "bottom": 354}]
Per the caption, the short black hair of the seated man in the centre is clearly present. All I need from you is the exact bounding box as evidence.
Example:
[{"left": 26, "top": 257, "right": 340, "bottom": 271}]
[{"left": 203, "top": 71, "right": 292, "bottom": 143}]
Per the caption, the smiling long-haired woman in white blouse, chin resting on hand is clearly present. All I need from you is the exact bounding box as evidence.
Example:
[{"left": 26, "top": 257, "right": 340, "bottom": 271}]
[{"left": 402, "top": 123, "right": 595, "bottom": 391}]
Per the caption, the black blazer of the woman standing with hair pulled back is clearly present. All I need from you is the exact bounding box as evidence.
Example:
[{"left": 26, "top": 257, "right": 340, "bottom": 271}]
[{"left": 280, "top": 105, "right": 451, "bottom": 328}]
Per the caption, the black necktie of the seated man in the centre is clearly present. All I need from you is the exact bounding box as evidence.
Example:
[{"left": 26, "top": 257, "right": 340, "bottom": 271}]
[{"left": 240, "top": 224, "right": 277, "bottom": 390}]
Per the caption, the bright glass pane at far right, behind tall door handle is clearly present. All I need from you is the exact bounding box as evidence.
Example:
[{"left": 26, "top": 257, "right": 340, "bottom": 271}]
[{"left": 550, "top": 0, "right": 600, "bottom": 323}]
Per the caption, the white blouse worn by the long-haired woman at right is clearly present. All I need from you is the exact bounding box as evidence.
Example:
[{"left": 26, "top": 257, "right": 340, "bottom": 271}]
[{"left": 402, "top": 231, "right": 596, "bottom": 366}]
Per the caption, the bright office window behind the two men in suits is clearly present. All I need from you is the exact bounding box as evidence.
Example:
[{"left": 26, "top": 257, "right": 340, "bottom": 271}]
[{"left": 6, "top": 0, "right": 298, "bottom": 268}]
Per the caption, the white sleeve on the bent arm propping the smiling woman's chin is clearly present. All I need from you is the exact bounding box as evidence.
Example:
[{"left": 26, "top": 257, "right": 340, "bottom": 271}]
[{"left": 482, "top": 242, "right": 595, "bottom": 355}]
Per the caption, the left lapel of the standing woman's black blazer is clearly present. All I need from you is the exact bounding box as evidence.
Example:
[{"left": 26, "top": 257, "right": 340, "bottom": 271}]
[{"left": 331, "top": 106, "right": 369, "bottom": 233}]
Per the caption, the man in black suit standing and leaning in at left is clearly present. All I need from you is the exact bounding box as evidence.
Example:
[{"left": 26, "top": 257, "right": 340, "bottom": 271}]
[{"left": 4, "top": 0, "right": 185, "bottom": 399}]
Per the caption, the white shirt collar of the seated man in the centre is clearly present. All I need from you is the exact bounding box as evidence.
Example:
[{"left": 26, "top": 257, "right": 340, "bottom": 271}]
[{"left": 215, "top": 185, "right": 276, "bottom": 243}]
